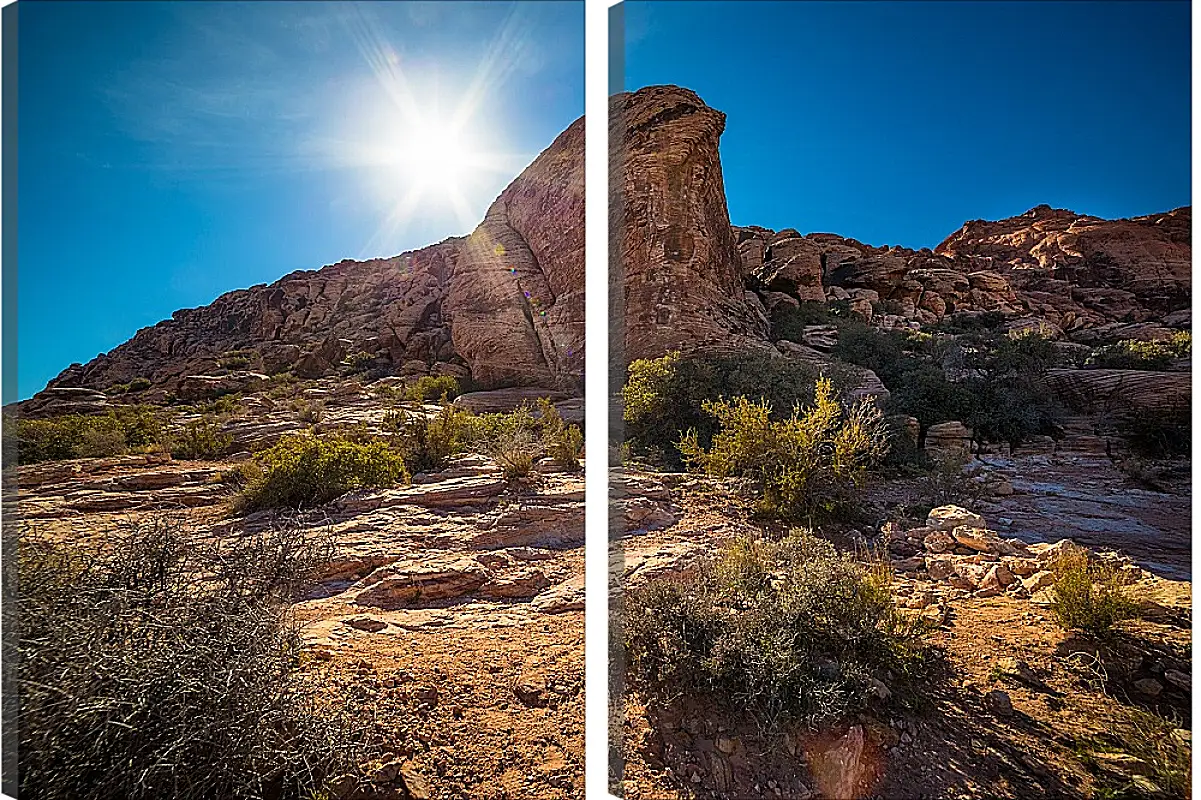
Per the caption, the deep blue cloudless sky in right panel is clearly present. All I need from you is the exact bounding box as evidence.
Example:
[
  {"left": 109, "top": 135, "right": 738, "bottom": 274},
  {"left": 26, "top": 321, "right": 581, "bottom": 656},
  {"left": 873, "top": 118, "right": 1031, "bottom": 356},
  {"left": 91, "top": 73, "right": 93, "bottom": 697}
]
[{"left": 625, "top": 0, "right": 1191, "bottom": 249}]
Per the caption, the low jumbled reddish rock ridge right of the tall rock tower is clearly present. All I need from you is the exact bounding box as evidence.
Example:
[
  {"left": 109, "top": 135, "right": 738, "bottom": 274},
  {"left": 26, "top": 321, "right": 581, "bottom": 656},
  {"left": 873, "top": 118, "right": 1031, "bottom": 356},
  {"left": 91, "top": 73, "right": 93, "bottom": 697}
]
[{"left": 735, "top": 205, "right": 1191, "bottom": 338}]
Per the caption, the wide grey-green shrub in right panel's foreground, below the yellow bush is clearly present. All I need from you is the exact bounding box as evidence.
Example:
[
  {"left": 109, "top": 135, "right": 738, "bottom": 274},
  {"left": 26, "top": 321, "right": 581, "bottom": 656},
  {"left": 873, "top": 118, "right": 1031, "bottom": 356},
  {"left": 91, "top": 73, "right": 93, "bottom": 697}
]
[{"left": 623, "top": 533, "right": 933, "bottom": 724}]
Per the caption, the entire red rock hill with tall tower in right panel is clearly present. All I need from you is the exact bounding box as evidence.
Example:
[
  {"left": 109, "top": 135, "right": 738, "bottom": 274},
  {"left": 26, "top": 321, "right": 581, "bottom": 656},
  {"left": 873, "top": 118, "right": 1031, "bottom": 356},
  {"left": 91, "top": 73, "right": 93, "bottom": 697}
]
[{"left": 610, "top": 86, "right": 1191, "bottom": 360}]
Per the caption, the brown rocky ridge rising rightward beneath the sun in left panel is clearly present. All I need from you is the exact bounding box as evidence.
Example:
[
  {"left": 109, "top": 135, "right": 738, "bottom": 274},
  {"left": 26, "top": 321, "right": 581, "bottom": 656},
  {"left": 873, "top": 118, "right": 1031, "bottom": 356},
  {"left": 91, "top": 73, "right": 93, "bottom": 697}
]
[{"left": 37, "top": 118, "right": 584, "bottom": 389}]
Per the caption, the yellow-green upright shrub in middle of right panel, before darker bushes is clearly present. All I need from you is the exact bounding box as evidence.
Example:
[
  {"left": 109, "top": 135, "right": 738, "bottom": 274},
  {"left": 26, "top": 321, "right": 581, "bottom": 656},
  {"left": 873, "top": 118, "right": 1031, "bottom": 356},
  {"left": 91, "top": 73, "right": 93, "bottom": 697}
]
[{"left": 680, "top": 378, "right": 888, "bottom": 521}]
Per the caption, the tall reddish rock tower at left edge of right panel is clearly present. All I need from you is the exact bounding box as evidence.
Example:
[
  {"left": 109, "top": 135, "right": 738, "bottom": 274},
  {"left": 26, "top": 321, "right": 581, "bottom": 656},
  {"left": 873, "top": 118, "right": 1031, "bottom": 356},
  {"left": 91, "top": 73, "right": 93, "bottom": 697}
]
[{"left": 609, "top": 86, "right": 766, "bottom": 362}]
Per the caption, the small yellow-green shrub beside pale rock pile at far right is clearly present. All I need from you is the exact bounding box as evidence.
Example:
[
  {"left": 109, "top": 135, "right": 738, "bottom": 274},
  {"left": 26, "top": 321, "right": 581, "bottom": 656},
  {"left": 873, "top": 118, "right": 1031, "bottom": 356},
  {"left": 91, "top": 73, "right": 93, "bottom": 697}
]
[{"left": 1051, "top": 551, "right": 1137, "bottom": 637}]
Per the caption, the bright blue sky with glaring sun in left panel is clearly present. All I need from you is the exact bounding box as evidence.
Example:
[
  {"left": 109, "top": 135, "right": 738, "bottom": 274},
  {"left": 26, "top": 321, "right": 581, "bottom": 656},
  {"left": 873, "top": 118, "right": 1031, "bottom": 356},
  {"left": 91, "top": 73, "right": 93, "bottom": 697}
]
[{"left": 17, "top": 0, "right": 584, "bottom": 402}]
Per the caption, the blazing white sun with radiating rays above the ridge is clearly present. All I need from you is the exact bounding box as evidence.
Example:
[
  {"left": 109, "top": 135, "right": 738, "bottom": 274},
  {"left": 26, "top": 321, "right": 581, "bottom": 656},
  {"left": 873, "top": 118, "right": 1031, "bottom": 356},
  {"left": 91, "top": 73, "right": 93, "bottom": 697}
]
[{"left": 326, "top": 4, "right": 530, "bottom": 256}]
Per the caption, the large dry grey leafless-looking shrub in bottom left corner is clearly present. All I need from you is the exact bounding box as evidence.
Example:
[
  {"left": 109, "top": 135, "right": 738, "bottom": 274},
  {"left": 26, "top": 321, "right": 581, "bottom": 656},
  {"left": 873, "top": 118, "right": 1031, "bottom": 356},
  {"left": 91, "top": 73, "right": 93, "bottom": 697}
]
[{"left": 13, "top": 519, "right": 362, "bottom": 800}]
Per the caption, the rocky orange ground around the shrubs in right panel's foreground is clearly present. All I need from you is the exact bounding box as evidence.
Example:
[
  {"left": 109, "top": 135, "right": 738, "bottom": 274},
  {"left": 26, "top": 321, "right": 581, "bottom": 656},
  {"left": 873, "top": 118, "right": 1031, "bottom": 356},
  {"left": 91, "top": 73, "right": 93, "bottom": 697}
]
[{"left": 611, "top": 468, "right": 1191, "bottom": 800}]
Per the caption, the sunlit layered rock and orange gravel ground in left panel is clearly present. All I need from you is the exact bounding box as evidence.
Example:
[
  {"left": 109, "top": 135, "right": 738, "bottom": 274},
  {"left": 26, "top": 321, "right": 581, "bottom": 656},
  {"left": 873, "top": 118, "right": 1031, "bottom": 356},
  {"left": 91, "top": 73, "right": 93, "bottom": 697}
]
[{"left": 10, "top": 378, "right": 584, "bottom": 800}]
